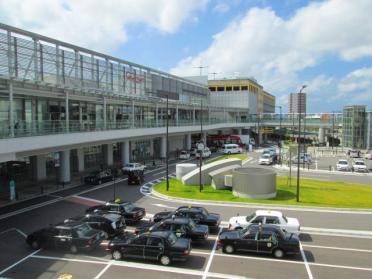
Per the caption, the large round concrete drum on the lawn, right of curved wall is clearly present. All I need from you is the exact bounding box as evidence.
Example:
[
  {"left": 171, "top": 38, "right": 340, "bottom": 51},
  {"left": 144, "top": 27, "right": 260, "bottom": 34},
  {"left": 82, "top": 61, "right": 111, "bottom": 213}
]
[{"left": 232, "top": 168, "right": 276, "bottom": 199}]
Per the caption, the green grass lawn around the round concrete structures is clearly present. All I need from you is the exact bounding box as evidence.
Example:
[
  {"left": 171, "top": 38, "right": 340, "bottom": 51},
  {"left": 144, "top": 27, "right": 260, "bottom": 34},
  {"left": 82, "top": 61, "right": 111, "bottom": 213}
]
[{"left": 154, "top": 176, "right": 372, "bottom": 208}]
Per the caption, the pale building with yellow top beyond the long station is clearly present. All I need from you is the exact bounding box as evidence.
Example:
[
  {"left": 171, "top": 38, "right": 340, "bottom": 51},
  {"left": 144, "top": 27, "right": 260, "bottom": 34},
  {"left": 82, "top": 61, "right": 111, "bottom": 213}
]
[{"left": 208, "top": 78, "right": 275, "bottom": 114}]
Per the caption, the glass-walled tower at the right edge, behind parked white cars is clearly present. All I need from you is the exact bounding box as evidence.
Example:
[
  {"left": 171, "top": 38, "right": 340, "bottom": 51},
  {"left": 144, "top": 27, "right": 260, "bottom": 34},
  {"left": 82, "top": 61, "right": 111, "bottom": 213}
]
[{"left": 342, "top": 105, "right": 370, "bottom": 149}]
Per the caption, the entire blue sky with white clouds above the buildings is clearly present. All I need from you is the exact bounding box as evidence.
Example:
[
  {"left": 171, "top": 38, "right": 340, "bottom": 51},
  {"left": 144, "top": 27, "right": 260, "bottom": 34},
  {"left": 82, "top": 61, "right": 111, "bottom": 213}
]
[{"left": 0, "top": 0, "right": 372, "bottom": 112}]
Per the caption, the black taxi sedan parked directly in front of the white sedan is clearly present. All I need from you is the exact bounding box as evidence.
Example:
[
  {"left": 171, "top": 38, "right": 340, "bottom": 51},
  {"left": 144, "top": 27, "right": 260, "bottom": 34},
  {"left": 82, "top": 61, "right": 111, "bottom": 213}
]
[{"left": 218, "top": 225, "right": 300, "bottom": 258}]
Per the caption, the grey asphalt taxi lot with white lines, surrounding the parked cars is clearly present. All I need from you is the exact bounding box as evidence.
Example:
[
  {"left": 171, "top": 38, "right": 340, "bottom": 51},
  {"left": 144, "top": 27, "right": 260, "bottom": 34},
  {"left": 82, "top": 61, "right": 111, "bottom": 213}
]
[{"left": 0, "top": 162, "right": 372, "bottom": 279}]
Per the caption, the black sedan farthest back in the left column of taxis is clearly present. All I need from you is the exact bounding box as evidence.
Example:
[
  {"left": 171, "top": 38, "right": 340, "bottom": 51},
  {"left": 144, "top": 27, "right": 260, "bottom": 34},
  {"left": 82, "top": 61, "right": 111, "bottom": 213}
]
[{"left": 86, "top": 199, "right": 146, "bottom": 223}]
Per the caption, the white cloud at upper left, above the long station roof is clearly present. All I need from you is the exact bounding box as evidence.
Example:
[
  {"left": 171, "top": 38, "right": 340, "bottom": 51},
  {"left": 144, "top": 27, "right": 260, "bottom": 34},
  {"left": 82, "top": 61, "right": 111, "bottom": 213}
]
[{"left": 0, "top": 0, "right": 207, "bottom": 51}]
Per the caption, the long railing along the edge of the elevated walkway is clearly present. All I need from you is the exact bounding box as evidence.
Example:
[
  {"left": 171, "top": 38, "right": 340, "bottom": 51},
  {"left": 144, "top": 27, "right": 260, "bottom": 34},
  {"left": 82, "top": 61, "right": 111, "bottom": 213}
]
[{"left": 0, "top": 115, "right": 342, "bottom": 138}]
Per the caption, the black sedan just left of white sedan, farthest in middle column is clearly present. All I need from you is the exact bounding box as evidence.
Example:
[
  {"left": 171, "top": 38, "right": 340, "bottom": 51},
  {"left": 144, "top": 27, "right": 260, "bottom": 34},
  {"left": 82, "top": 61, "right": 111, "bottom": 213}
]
[{"left": 153, "top": 206, "right": 221, "bottom": 231}]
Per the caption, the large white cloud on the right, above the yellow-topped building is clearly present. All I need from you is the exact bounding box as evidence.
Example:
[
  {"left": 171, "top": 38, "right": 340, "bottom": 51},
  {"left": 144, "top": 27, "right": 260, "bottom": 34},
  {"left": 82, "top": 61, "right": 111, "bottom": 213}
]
[{"left": 171, "top": 0, "right": 372, "bottom": 94}]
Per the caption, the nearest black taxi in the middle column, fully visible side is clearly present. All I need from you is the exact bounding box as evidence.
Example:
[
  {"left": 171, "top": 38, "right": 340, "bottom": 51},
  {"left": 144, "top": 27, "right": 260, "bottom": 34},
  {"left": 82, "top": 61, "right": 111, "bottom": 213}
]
[{"left": 106, "top": 231, "right": 191, "bottom": 265}]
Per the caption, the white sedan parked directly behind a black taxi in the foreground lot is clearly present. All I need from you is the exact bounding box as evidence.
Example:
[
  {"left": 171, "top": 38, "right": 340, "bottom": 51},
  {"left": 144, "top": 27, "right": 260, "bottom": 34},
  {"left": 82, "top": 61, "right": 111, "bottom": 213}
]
[{"left": 229, "top": 210, "right": 300, "bottom": 235}]
